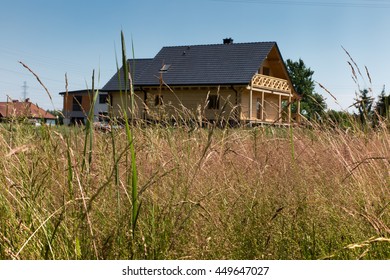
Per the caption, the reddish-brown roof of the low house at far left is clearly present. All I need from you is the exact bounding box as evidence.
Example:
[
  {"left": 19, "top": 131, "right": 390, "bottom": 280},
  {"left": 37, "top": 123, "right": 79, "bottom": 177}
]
[{"left": 0, "top": 101, "right": 56, "bottom": 119}]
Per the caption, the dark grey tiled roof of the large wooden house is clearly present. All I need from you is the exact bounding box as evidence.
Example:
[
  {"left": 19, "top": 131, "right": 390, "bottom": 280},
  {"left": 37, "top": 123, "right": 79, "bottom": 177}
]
[{"left": 102, "top": 42, "right": 278, "bottom": 91}]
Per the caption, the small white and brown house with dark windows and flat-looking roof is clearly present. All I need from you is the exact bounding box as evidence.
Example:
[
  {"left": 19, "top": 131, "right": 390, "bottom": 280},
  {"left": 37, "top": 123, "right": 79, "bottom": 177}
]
[{"left": 60, "top": 90, "right": 108, "bottom": 124}]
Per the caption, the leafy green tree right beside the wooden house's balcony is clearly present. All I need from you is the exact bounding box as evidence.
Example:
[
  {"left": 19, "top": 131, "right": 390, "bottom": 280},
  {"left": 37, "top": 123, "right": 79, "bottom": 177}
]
[{"left": 286, "top": 59, "right": 327, "bottom": 119}]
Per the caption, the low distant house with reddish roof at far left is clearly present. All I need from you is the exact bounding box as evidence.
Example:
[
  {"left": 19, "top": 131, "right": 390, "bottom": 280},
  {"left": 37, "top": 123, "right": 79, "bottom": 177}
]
[{"left": 0, "top": 99, "right": 56, "bottom": 124}]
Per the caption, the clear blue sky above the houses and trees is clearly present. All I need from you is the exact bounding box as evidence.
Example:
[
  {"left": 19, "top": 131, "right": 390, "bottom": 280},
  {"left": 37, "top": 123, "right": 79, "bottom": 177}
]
[{"left": 0, "top": 0, "right": 390, "bottom": 109}]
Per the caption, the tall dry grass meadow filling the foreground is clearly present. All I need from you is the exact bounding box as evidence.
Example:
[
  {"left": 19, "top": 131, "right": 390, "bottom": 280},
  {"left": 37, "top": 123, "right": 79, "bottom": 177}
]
[{"left": 0, "top": 117, "right": 390, "bottom": 260}]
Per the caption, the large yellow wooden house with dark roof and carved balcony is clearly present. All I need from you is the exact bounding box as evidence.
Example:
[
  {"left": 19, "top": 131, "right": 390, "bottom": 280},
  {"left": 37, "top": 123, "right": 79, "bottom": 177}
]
[{"left": 100, "top": 39, "right": 300, "bottom": 124}]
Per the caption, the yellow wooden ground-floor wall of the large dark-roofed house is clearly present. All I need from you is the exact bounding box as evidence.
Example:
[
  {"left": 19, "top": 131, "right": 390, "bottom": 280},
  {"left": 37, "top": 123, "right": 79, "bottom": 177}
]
[{"left": 111, "top": 87, "right": 294, "bottom": 122}]
